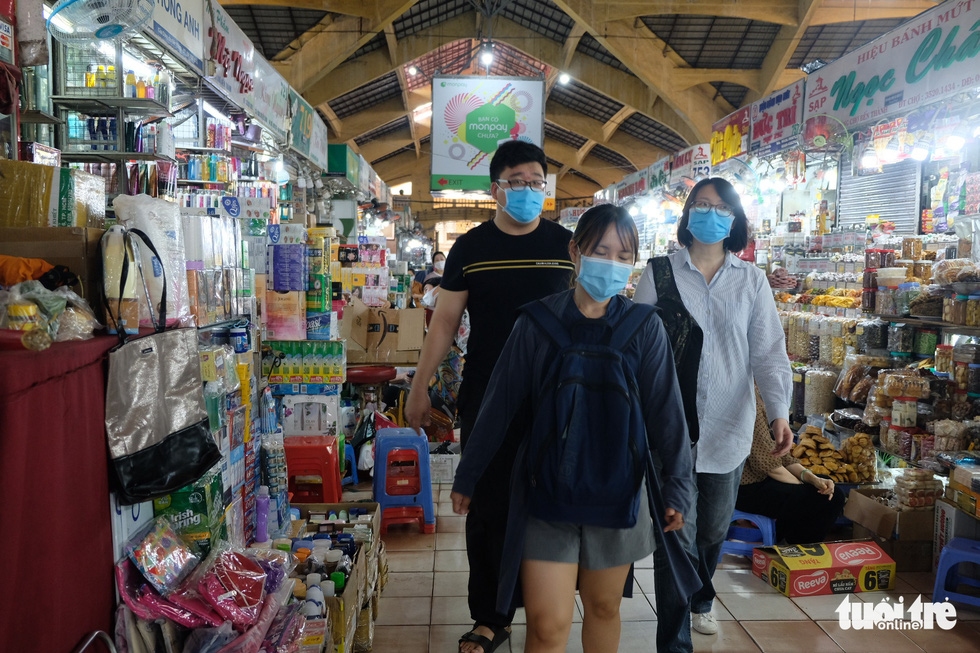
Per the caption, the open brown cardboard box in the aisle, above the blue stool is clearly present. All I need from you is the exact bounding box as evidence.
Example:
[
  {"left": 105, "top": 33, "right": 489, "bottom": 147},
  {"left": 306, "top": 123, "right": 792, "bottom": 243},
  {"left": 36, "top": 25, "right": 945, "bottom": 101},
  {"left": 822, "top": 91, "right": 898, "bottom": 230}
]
[{"left": 340, "top": 297, "right": 425, "bottom": 365}]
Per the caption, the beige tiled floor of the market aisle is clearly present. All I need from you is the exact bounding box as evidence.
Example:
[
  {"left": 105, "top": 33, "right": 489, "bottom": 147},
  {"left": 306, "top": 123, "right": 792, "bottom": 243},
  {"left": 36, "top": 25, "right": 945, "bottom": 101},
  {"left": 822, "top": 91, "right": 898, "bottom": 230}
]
[{"left": 359, "top": 486, "right": 980, "bottom": 653}]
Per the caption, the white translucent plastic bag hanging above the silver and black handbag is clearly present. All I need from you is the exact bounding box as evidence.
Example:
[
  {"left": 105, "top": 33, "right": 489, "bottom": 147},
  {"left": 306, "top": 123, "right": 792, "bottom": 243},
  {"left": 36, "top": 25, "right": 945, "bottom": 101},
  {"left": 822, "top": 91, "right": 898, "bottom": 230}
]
[{"left": 112, "top": 195, "right": 194, "bottom": 327}]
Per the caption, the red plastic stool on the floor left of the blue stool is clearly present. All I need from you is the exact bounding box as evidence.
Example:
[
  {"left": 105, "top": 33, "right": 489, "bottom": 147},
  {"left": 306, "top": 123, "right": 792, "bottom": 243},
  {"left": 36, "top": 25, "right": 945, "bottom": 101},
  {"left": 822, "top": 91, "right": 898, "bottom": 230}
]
[{"left": 283, "top": 435, "right": 341, "bottom": 503}]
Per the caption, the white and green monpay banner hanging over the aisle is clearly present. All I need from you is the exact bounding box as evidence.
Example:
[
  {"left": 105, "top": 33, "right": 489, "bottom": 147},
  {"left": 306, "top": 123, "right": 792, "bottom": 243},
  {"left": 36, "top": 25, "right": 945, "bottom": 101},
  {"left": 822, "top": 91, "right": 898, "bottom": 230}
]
[{"left": 430, "top": 75, "right": 544, "bottom": 191}]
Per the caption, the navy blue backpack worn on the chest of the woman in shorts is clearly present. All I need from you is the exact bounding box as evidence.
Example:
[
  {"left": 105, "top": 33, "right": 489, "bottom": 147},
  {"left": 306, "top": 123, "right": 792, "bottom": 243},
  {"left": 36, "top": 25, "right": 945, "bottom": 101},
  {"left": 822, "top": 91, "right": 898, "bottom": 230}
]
[{"left": 521, "top": 300, "right": 656, "bottom": 528}]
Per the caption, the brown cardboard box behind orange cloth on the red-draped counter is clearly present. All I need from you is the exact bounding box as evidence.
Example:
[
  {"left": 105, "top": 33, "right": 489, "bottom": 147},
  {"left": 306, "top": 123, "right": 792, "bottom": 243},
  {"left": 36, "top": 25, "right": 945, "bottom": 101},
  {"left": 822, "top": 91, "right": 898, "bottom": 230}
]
[{"left": 0, "top": 227, "right": 104, "bottom": 310}]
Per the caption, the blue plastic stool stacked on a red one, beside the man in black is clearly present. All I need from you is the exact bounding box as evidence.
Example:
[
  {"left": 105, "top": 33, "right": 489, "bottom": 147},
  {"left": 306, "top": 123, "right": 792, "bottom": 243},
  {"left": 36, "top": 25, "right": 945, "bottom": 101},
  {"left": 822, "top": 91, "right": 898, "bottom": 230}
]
[{"left": 374, "top": 428, "right": 436, "bottom": 534}]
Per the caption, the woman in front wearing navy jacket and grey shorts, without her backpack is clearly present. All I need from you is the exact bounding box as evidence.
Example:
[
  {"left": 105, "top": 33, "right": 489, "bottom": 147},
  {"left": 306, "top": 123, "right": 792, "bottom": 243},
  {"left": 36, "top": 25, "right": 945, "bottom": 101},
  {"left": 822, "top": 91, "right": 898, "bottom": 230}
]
[{"left": 452, "top": 204, "right": 696, "bottom": 653}]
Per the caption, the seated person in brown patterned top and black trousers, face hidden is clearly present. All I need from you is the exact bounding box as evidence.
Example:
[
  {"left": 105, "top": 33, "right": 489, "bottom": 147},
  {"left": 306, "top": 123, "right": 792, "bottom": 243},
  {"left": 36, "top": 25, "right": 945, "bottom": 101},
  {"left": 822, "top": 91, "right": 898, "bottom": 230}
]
[{"left": 735, "top": 393, "right": 847, "bottom": 544}]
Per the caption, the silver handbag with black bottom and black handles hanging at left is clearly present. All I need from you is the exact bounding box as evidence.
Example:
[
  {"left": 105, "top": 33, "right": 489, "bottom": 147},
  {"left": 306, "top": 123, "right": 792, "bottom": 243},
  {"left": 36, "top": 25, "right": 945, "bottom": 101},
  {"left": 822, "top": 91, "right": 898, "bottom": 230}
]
[{"left": 105, "top": 229, "right": 221, "bottom": 505}]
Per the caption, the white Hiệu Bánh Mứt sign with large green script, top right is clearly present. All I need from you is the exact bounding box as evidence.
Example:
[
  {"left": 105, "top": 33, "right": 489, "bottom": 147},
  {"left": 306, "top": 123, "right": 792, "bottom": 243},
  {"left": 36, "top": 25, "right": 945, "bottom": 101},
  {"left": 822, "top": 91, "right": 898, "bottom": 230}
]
[{"left": 806, "top": 0, "right": 980, "bottom": 127}]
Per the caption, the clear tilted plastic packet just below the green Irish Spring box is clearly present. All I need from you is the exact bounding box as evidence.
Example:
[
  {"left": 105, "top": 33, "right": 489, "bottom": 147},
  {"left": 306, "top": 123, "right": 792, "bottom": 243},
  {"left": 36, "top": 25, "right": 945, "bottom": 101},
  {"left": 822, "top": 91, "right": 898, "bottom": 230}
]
[{"left": 126, "top": 517, "right": 200, "bottom": 596}]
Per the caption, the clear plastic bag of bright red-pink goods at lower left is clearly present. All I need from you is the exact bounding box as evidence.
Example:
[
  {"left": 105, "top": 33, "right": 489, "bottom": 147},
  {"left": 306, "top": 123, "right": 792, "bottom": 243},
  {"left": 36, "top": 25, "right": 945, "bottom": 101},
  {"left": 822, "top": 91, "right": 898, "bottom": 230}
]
[{"left": 198, "top": 543, "right": 266, "bottom": 627}]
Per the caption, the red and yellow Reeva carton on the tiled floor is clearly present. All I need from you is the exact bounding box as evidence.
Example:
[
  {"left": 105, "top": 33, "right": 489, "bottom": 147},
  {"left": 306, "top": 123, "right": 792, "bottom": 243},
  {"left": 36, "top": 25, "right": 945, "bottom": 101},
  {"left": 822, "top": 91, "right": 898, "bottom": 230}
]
[{"left": 752, "top": 541, "right": 895, "bottom": 597}]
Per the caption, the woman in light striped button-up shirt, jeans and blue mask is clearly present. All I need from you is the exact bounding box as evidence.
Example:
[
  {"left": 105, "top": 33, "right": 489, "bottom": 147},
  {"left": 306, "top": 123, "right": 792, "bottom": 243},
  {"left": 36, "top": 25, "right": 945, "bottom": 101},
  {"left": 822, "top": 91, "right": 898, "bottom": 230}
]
[{"left": 633, "top": 178, "right": 793, "bottom": 651}]
